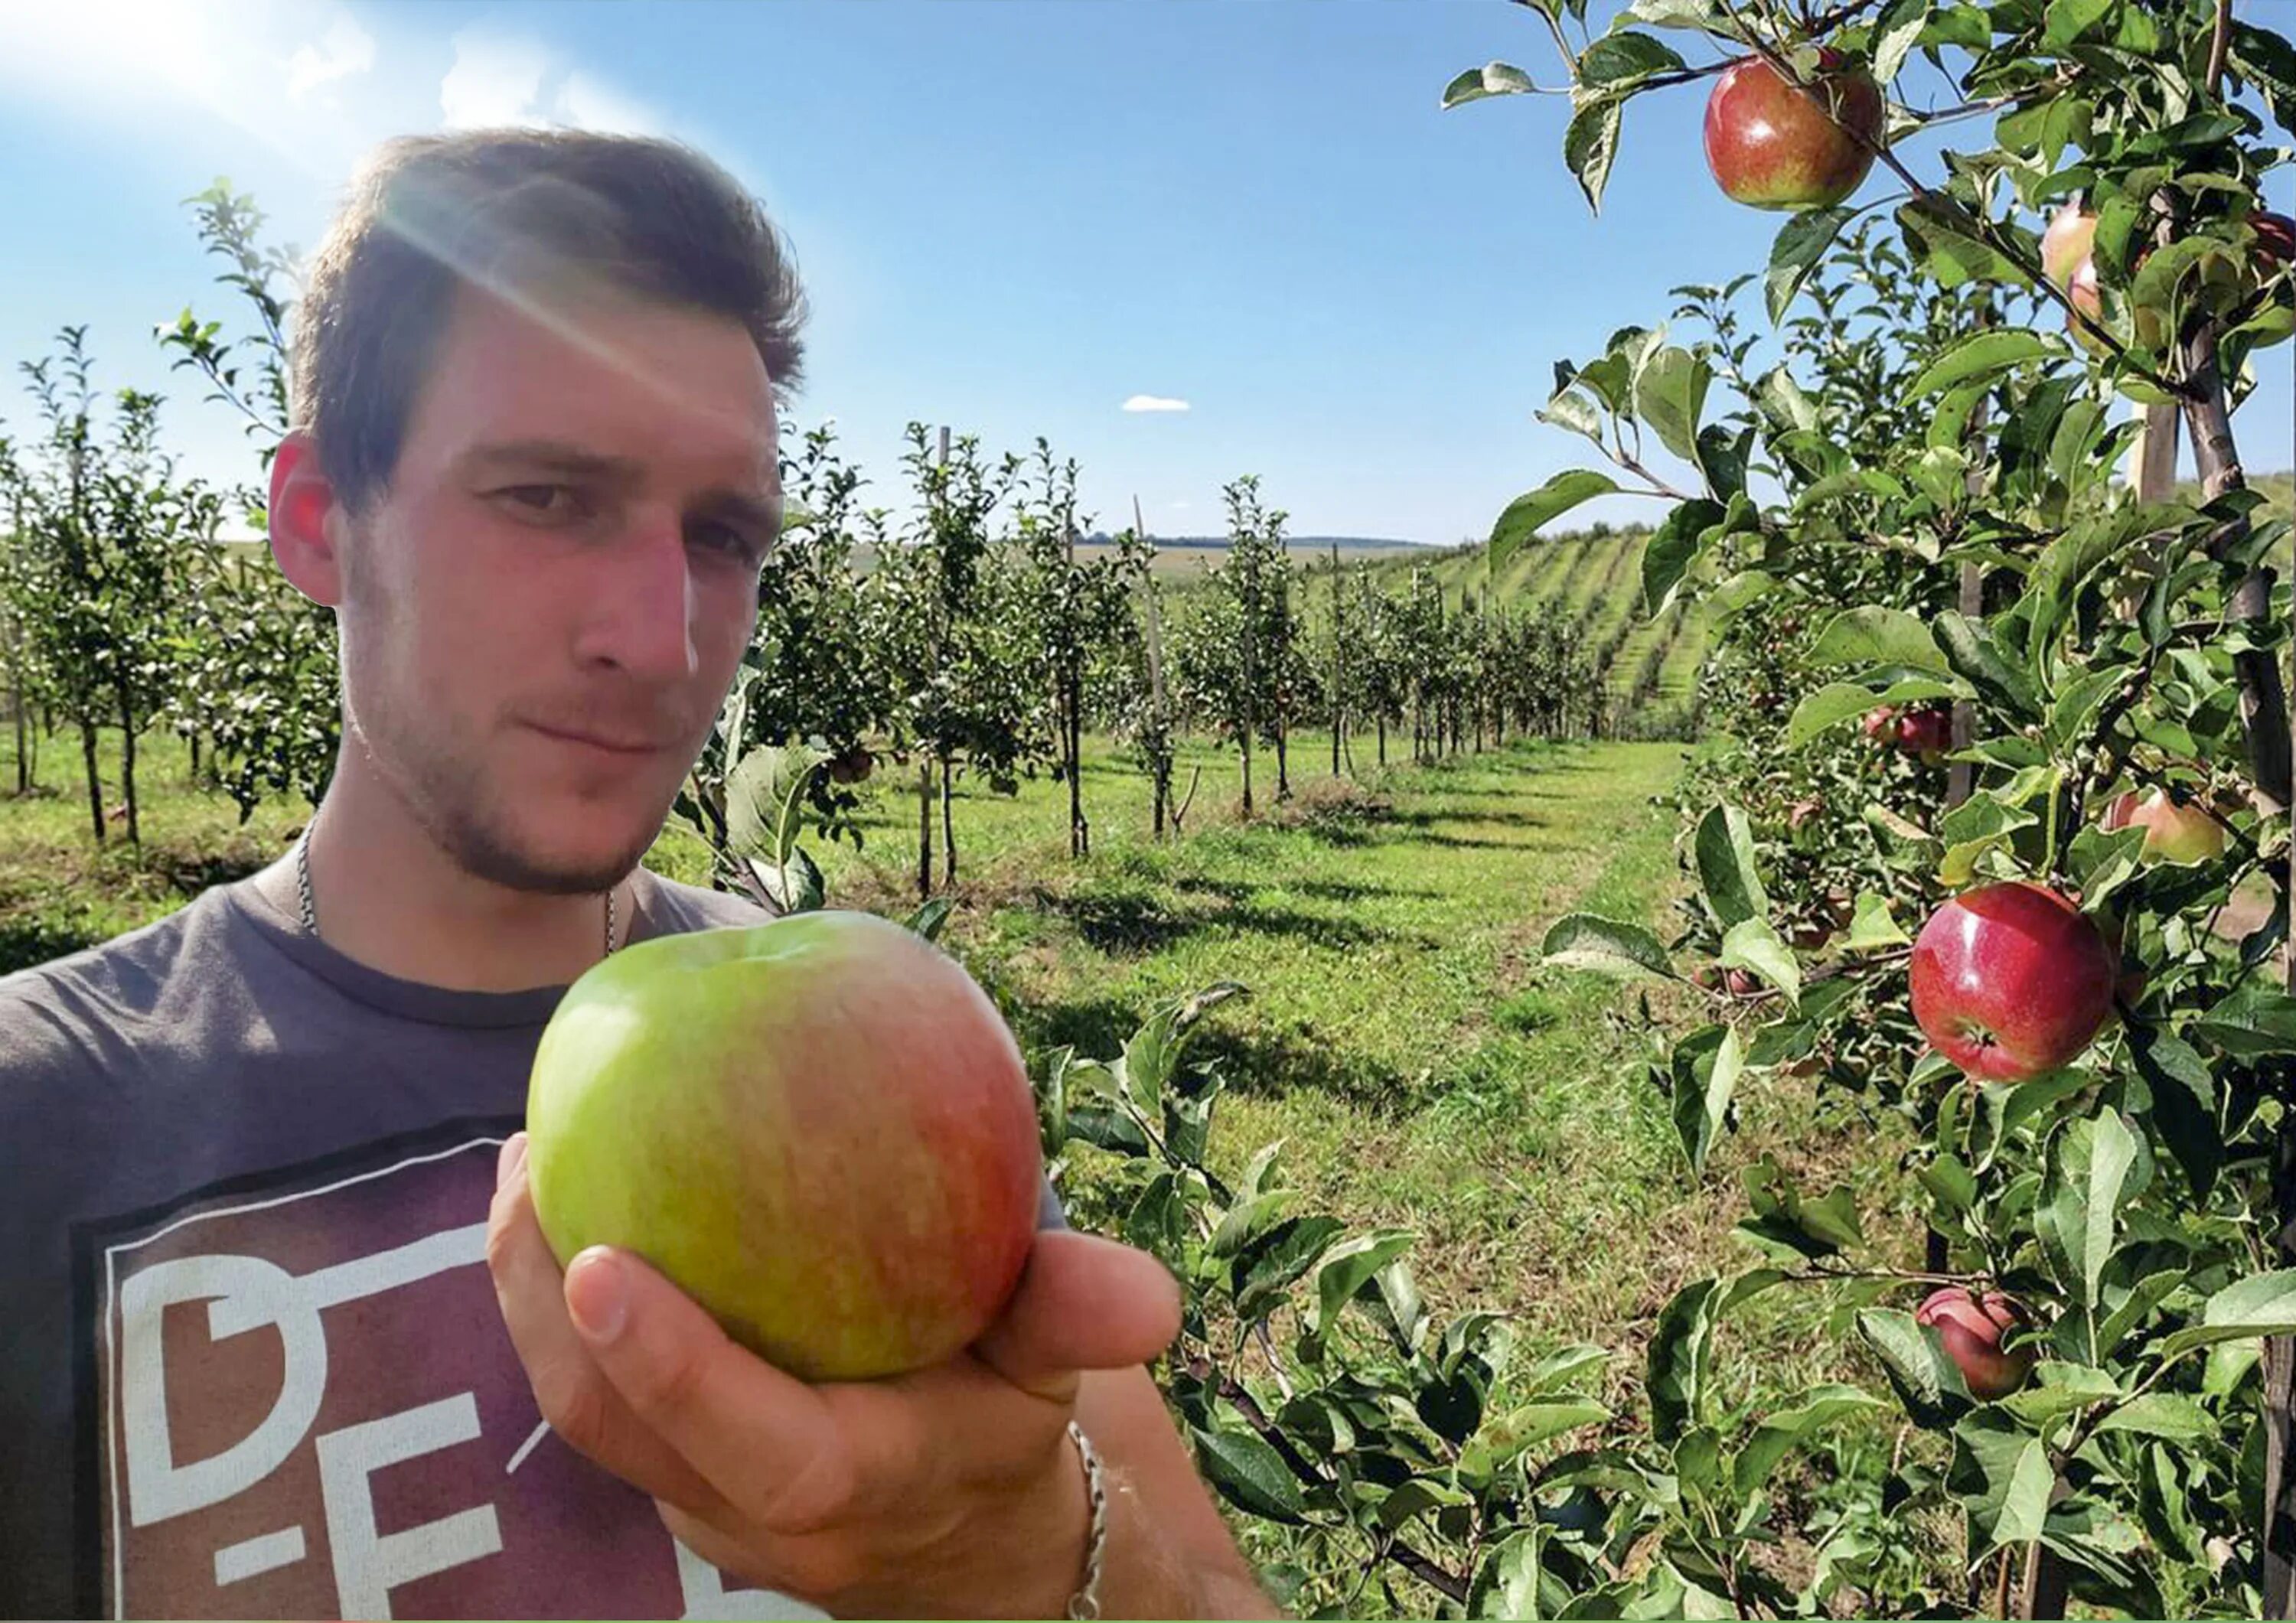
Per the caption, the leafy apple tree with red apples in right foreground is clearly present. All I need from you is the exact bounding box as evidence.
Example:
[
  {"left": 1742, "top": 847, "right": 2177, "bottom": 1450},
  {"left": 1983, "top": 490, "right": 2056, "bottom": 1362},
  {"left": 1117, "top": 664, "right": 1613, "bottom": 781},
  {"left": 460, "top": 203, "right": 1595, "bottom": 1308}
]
[{"left": 1444, "top": 0, "right": 2296, "bottom": 1616}]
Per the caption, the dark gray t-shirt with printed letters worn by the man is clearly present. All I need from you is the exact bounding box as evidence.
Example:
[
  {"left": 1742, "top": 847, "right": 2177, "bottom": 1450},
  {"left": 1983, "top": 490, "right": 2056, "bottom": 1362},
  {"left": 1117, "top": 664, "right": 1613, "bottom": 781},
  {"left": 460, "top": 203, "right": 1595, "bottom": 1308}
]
[{"left": 0, "top": 870, "right": 1061, "bottom": 1618}]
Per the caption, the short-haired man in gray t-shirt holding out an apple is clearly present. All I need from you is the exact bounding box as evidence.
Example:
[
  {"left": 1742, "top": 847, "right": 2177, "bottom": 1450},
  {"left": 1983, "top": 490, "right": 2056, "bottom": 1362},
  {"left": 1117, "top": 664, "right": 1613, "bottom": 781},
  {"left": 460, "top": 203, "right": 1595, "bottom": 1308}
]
[{"left": 0, "top": 131, "right": 1272, "bottom": 1616}]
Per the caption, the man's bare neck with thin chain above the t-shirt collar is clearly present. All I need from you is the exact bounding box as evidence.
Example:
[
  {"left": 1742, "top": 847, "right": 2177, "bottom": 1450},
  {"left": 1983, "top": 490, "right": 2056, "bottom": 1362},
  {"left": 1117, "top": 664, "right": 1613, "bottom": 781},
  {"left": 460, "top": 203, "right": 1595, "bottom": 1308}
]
[{"left": 259, "top": 785, "right": 645, "bottom": 992}]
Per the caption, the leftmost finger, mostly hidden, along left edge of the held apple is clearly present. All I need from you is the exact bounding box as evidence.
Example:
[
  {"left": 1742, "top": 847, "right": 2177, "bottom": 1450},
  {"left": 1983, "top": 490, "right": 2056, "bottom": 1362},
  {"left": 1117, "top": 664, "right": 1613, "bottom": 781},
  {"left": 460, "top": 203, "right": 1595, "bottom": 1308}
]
[{"left": 487, "top": 1134, "right": 723, "bottom": 1515}]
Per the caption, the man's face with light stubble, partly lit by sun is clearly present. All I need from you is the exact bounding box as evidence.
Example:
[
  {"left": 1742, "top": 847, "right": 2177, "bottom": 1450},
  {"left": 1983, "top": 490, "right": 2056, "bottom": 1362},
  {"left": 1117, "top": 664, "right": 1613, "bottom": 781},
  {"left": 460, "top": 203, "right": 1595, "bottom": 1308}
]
[{"left": 338, "top": 273, "right": 781, "bottom": 895}]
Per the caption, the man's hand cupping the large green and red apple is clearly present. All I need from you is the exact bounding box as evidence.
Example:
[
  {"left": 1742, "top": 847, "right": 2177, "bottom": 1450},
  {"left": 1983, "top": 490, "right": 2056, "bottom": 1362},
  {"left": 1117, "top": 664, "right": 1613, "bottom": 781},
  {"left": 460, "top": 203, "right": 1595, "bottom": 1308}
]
[{"left": 487, "top": 1134, "right": 1180, "bottom": 1618}]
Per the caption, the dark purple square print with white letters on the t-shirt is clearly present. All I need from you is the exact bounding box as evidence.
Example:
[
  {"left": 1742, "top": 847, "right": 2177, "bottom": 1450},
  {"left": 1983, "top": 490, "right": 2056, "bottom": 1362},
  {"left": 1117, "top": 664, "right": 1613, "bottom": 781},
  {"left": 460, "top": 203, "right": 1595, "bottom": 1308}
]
[{"left": 78, "top": 1123, "right": 822, "bottom": 1618}]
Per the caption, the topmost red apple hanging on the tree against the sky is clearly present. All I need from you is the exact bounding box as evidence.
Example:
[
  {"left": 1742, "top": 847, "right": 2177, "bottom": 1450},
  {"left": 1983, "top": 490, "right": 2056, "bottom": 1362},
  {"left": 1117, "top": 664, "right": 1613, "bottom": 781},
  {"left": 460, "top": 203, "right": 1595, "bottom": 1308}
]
[{"left": 1706, "top": 46, "right": 1883, "bottom": 209}]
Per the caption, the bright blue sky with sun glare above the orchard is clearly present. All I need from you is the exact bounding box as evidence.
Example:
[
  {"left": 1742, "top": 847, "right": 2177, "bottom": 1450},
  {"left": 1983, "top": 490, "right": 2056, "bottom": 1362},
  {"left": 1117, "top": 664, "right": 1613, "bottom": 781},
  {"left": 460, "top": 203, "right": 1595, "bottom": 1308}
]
[{"left": 0, "top": 0, "right": 2296, "bottom": 544}]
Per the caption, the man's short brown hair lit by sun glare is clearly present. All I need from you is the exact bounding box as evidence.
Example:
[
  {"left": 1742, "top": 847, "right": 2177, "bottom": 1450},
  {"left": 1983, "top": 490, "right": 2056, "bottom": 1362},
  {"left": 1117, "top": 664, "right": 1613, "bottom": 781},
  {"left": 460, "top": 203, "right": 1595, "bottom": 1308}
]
[{"left": 289, "top": 129, "right": 806, "bottom": 512}]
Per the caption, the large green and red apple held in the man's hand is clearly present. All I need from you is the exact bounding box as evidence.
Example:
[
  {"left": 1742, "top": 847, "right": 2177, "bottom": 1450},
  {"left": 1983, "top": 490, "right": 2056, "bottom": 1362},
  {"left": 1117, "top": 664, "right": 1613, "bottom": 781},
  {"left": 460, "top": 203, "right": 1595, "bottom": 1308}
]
[{"left": 526, "top": 911, "right": 1042, "bottom": 1380}]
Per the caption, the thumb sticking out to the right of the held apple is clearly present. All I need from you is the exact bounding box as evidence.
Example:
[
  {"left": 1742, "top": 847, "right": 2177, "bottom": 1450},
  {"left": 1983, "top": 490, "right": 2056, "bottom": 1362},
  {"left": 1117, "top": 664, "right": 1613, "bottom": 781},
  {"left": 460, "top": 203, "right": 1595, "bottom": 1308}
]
[{"left": 974, "top": 1228, "right": 1180, "bottom": 1403}]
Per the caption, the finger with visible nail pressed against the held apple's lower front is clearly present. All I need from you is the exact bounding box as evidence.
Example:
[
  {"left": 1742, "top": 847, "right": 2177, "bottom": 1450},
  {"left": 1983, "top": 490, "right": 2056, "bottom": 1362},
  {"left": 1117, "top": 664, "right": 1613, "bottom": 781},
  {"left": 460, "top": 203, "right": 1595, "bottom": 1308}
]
[{"left": 565, "top": 1247, "right": 868, "bottom": 1533}]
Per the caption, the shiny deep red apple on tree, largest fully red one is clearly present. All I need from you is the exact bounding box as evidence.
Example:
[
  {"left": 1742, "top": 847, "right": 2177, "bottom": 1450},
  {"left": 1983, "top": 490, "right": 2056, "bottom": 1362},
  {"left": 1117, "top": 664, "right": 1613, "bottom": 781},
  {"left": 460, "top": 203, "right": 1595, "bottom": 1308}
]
[{"left": 1910, "top": 879, "right": 2119, "bottom": 1081}]
